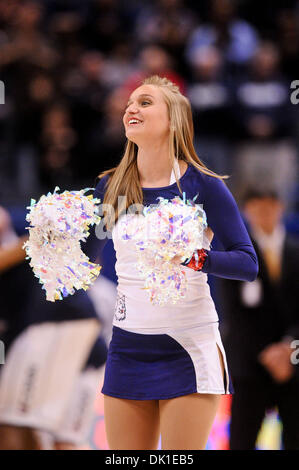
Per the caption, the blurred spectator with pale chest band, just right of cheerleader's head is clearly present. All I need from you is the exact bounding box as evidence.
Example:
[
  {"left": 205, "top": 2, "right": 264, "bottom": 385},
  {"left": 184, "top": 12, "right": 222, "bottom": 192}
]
[{"left": 187, "top": 46, "right": 233, "bottom": 174}]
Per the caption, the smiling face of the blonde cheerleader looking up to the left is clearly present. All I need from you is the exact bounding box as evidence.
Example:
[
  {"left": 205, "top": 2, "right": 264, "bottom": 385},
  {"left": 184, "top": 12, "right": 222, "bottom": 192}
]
[{"left": 123, "top": 85, "right": 169, "bottom": 145}]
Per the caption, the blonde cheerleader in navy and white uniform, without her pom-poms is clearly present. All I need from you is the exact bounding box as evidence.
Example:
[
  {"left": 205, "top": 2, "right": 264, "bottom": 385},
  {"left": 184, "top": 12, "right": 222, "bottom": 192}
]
[{"left": 95, "top": 76, "right": 258, "bottom": 449}]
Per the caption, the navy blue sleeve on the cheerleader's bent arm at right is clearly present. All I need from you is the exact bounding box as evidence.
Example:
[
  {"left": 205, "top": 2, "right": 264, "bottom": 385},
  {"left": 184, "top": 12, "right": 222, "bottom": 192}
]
[{"left": 202, "top": 175, "right": 258, "bottom": 281}]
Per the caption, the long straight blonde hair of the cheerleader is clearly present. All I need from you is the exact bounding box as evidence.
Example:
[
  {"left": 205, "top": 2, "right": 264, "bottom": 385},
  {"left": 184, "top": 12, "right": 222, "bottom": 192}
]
[{"left": 99, "top": 75, "right": 229, "bottom": 229}]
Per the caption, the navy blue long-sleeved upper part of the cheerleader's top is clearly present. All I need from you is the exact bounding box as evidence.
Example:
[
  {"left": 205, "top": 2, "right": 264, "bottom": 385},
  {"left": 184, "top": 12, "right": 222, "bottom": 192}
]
[{"left": 94, "top": 165, "right": 258, "bottom": 281}]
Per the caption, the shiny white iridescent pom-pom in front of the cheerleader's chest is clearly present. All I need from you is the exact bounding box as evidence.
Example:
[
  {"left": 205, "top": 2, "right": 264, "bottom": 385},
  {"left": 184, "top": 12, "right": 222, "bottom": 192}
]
[{"left": 120, "top": 195, "right": 207, "bottom": 306}]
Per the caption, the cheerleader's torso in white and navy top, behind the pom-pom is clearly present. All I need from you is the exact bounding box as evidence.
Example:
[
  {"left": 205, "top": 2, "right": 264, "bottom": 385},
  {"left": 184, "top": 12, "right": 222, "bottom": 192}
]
[{"left": 112, "top": 162, "right": 218, "bottom": 333}]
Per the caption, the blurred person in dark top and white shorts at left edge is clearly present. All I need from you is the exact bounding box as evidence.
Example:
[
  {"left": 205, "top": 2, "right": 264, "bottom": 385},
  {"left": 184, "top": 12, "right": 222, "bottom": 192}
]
[{"left": 0, "top": 207, "right": 107, "bottom": 450}]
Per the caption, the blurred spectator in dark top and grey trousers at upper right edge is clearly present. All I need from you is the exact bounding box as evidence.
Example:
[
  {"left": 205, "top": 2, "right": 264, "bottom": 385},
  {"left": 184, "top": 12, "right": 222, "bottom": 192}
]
[{"left": 234, "top": 41, "right": 297, "bottom": 207}]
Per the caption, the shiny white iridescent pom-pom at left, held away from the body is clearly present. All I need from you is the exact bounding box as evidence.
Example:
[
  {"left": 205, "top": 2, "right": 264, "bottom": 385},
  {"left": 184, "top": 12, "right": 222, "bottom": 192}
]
[{"left": 24, "top": 188, "right": 101, "bottom": 302}]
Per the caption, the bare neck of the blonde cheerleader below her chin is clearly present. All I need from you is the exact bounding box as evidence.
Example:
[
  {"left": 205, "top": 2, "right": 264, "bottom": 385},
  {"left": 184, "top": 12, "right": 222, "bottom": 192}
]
[{"left": 137, "top": 142, "right": 172, "bottom": 186}]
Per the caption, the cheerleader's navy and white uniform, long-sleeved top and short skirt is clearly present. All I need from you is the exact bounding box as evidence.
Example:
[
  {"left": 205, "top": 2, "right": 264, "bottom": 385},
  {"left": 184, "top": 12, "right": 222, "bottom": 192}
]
[{"left": 95, "top": 165, "right": 258, "bottom": 400}]
